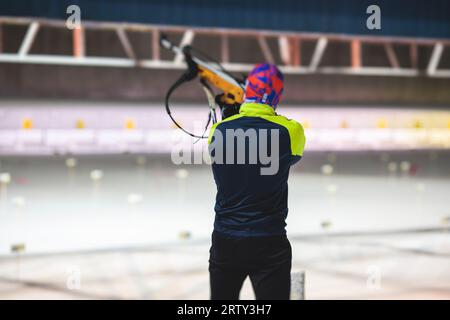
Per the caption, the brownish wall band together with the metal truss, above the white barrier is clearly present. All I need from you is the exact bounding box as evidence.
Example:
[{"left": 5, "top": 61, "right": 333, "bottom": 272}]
[{"left": 0, "top": 17, "right": 450, "bottom": 105}]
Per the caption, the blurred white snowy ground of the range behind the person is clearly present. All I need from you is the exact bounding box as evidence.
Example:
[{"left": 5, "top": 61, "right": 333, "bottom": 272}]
[{"left": 0, "top": 151, "right": 450, "bottom": 299}]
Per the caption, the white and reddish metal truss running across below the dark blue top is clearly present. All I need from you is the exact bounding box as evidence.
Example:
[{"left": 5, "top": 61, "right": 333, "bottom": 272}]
[{"left": 0, "top": 17, "right": 450, "bottom": 78}]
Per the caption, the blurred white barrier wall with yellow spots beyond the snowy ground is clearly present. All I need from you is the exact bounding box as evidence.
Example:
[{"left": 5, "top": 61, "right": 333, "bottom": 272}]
[{"left": 0, "top": 101, "right": 450, "bottom": 155}]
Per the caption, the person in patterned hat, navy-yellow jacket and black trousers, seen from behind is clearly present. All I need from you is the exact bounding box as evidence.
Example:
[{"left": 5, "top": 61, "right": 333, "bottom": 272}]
[{"left": 209, "top": 64, "right": 305, "bottom": 299}]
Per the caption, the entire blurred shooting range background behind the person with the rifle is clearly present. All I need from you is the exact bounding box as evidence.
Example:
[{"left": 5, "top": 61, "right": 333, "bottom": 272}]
[{"left": 0, "top": 0, "right": 450, "bottom": 299}]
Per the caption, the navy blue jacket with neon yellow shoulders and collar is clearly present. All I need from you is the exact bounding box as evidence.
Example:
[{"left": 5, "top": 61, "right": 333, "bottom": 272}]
[{"left": 208, "top": 103, "right": 305, "bottom": 237}]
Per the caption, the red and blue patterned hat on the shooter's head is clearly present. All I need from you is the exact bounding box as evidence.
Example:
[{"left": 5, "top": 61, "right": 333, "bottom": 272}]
[{"left": 245, "top": 63, "right": 284, "bottom": 109}]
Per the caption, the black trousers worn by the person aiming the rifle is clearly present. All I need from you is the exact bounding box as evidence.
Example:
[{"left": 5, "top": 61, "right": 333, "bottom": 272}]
[{"left": 209, "top": 232, "right": 292, "bottom": 300}]
